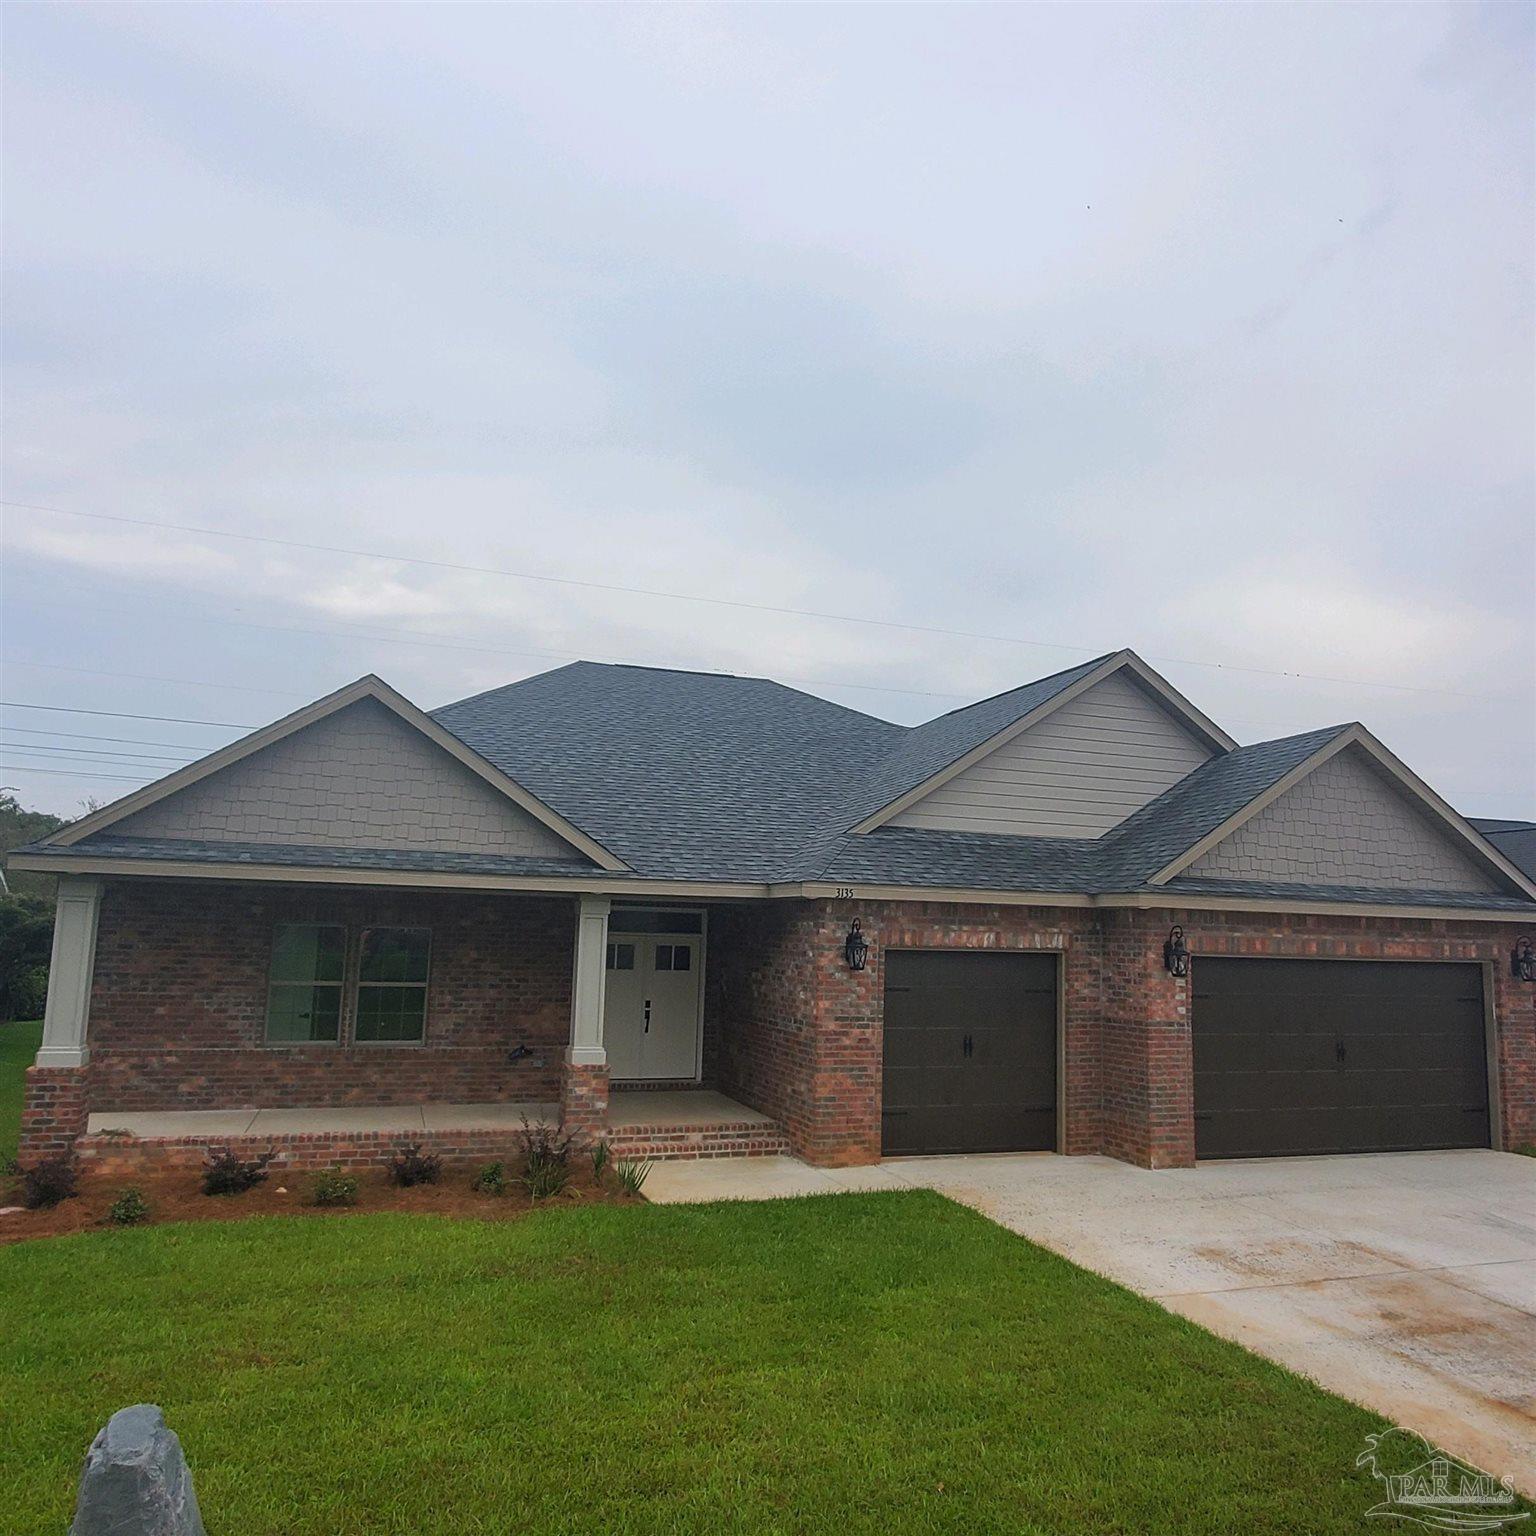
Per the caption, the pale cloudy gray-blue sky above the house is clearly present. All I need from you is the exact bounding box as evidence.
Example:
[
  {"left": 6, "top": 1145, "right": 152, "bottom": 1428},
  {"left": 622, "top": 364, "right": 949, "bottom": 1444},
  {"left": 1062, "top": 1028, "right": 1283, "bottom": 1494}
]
[{"left": 0, "top": 5, "right": 1536, "bottom": 817}]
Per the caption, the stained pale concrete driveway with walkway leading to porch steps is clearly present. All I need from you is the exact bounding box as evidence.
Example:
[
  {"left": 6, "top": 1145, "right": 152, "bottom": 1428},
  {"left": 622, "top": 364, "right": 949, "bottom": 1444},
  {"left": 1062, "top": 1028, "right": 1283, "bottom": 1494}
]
[{"left": 645, "top": 1152, "right": 1536, "bottom": 1493}]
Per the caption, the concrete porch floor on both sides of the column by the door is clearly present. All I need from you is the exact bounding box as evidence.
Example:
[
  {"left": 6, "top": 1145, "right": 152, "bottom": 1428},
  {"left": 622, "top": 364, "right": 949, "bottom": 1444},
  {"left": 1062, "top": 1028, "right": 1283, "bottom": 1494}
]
[{"left": 86, "top": 1087, "right": 774, "bottom": 1141}]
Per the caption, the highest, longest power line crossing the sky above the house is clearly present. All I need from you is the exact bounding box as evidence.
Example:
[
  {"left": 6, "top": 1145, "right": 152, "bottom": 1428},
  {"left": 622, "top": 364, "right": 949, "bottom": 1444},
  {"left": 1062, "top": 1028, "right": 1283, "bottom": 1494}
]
[{"left": 0, "top": 499, "right": 1499, "bottom": 699}]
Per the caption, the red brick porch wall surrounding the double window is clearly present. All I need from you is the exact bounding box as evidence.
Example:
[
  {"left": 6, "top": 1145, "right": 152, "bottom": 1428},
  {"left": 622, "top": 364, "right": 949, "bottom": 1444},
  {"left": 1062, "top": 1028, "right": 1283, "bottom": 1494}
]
[{"left": 89, "top": 880, "right": 574, "bottom": 1111}]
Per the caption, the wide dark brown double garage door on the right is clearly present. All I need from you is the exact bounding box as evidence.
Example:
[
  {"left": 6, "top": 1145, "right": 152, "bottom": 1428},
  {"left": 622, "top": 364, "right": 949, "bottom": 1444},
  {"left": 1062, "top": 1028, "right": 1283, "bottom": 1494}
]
[{"left": 1193, "top": 957, "right": 1488, "bottom": 1157}]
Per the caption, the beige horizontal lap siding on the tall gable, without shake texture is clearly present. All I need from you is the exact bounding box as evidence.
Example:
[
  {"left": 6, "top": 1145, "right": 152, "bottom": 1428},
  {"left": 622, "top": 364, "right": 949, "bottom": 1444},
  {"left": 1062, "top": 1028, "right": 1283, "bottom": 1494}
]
[{"left": 889, "top": 673, "right": 1212, "bottom": 837}]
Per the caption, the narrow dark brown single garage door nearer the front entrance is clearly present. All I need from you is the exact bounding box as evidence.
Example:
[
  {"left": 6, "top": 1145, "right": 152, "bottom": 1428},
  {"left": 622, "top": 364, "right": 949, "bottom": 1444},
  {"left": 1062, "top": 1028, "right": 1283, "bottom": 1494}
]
[{"left": 882, "top": 949, "right": 1057, "bottom": 1154}]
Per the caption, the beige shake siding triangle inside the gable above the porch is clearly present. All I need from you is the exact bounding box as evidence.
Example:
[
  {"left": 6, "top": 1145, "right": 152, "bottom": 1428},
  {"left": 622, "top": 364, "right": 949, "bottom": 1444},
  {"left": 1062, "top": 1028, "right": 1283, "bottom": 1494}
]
[{"left": 112, "top": 699, "right": 582, "bottom": 860}]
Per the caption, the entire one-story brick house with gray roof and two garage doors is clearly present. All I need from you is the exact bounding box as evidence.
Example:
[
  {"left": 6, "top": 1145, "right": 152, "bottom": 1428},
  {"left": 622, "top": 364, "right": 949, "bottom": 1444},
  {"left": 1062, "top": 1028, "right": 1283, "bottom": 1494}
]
[{"left": 11, "top": 651, "right": 1536, "bottom": 1167}]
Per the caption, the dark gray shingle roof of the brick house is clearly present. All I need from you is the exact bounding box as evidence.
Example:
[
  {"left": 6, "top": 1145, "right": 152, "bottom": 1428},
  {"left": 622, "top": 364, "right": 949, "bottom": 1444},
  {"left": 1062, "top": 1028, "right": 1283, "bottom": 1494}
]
[{"left": 21, "top": 657, "right": 1536, "bottom": 911}]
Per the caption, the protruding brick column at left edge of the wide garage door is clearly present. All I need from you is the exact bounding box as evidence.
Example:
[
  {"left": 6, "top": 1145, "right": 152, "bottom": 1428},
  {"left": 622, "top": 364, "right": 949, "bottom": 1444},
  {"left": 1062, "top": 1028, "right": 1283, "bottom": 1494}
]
[{"left": 1101, "top": 911, "right": 1200, "bottom": 1167}]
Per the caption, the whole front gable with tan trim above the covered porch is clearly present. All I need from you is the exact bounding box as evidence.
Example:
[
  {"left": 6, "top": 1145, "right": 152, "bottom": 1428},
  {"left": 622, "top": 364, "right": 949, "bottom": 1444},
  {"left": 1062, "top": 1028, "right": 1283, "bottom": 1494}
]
[{"left": 49, "top": 677, "right": 624, "bottom": 869}]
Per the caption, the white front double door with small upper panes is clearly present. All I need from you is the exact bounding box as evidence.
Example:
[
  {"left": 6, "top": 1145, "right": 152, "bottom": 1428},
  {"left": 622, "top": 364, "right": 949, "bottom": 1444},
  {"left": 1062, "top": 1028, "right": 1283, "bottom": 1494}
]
[{"left": 602, "top": 932, "right": 703, "bottom": 1083}]
